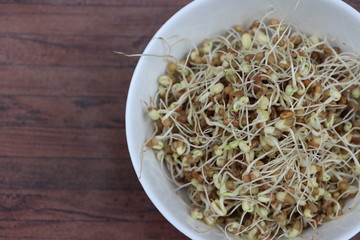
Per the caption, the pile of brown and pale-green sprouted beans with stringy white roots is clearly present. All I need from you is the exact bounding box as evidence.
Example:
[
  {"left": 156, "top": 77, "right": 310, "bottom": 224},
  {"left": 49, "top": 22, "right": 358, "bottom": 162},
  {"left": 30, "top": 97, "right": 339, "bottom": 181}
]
[{"left": 146, "top": 15, "right": 360, "bottom": 239}]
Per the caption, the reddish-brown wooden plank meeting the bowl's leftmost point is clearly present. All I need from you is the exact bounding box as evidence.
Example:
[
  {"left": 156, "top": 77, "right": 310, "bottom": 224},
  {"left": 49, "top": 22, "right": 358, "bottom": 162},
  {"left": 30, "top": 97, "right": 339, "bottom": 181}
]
[{"left": 0, "top": 95, "right": 126, "bottom": 129}]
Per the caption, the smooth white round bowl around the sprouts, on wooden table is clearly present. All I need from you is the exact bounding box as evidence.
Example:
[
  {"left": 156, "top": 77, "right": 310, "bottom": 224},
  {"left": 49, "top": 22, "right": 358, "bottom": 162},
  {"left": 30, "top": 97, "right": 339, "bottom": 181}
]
[{"left": 126, "top": 0, "right": 360, "bottom": 240}]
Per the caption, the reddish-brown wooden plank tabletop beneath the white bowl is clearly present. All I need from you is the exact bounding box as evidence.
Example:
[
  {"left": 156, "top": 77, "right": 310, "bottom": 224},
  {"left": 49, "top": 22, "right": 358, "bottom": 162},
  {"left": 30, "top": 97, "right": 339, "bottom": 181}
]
[{"left": 0, "top": 0, "right": 360, "bottom": 240}]
